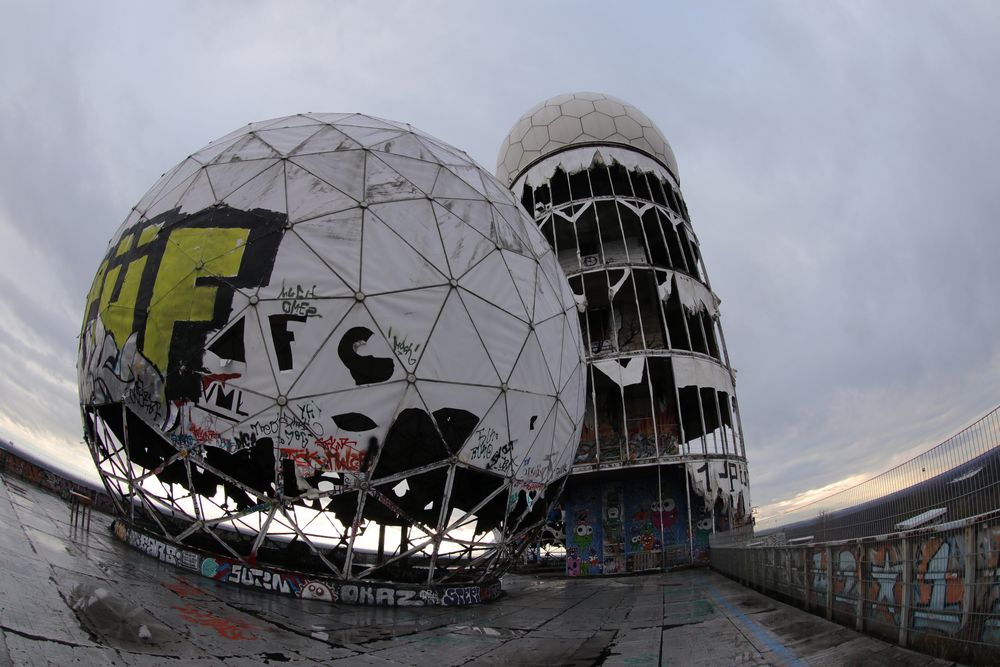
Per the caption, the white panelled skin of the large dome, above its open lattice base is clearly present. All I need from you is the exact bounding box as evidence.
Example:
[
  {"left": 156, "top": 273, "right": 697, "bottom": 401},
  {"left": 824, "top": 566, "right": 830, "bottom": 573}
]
[{"left": 79, "top": 114, "right": 586, "bottom": 580}]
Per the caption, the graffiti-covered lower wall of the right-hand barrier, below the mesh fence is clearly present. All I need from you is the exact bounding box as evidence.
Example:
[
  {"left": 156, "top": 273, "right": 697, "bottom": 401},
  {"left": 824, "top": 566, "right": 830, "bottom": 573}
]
[{"left": 711, "top": 511, "right": 1000, "bottom": 665}]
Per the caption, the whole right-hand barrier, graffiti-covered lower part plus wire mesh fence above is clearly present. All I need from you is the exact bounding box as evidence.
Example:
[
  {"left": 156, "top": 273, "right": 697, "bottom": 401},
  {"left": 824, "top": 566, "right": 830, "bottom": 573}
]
[{"left": 711, "top": 407, "right": 1000, "bottom": 664}]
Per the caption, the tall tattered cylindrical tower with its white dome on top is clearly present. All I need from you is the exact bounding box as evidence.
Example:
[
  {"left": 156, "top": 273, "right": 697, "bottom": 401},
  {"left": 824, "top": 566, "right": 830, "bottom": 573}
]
[{"left": 496, "top": 93, "right": 750, "bottom": 573}]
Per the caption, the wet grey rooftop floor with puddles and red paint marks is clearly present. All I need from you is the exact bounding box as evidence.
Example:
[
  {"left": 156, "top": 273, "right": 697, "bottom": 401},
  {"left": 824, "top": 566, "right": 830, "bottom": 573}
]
[{"left": 0, "top": 476, "right": 968, "bottom": 667}]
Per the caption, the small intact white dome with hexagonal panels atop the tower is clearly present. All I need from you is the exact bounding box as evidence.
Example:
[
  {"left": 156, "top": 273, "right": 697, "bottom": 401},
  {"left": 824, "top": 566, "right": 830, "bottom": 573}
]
[{"left": 496, "top": 93, "right": 680, "bottom": 186}]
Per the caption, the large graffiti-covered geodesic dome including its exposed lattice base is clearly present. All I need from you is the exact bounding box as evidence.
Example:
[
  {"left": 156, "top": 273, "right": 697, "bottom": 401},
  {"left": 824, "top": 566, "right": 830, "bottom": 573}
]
[{"left": 79, "top": 114, "right": 586, "bottom": 596}]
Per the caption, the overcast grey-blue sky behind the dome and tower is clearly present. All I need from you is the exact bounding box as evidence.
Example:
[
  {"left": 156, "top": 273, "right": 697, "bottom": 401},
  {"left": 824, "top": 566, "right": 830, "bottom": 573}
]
[{"left": 0, "top": 0, "right": 1000, "bottom": 520}]
